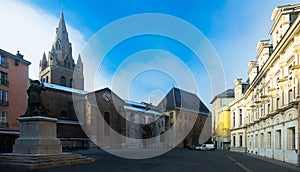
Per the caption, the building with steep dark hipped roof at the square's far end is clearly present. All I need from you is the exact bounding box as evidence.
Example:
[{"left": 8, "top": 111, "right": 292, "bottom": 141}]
[{"left": 158, "top": 88, "right": 211, "bottom": 148}]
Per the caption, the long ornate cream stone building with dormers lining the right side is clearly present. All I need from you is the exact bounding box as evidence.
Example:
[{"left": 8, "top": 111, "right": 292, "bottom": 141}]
[{"left": 229, "top": 4, "right": 300, "bottom": 164}]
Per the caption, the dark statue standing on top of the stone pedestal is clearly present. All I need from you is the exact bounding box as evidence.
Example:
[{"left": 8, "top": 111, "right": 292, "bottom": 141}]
[{"left": 22, "top": 80, "right": 48, "bottom": 117}]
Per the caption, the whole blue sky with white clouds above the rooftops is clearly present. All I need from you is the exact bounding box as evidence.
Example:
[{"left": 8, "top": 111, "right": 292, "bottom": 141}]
[{"left": 0, "top": 0, "right": 299, "bottom": 108}]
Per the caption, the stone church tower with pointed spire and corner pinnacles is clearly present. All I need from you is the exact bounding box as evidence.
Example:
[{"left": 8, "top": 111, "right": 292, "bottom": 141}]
[{"left": 39, "top": 12, "right": 84, "bottom": 90}]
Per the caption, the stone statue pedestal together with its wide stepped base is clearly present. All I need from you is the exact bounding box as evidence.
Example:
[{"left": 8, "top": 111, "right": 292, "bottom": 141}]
[{"left": 0, "top": 116, "right": 95, "bottom": 171}]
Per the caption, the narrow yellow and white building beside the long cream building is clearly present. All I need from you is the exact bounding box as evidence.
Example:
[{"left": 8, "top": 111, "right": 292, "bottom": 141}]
[{"left": 211, "top": 89, "right": 234, "bottom": 150}]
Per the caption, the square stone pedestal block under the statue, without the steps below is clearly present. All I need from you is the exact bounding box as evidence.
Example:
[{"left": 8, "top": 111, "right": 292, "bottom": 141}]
[{"left": 13, "top": 116, "right": 62, "bottom": 154}]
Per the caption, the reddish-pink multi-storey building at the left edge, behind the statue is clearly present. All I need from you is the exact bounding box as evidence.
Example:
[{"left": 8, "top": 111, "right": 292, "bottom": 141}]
[{"left": 0, "top": 49, "right": 30, "bottom": 152}]
